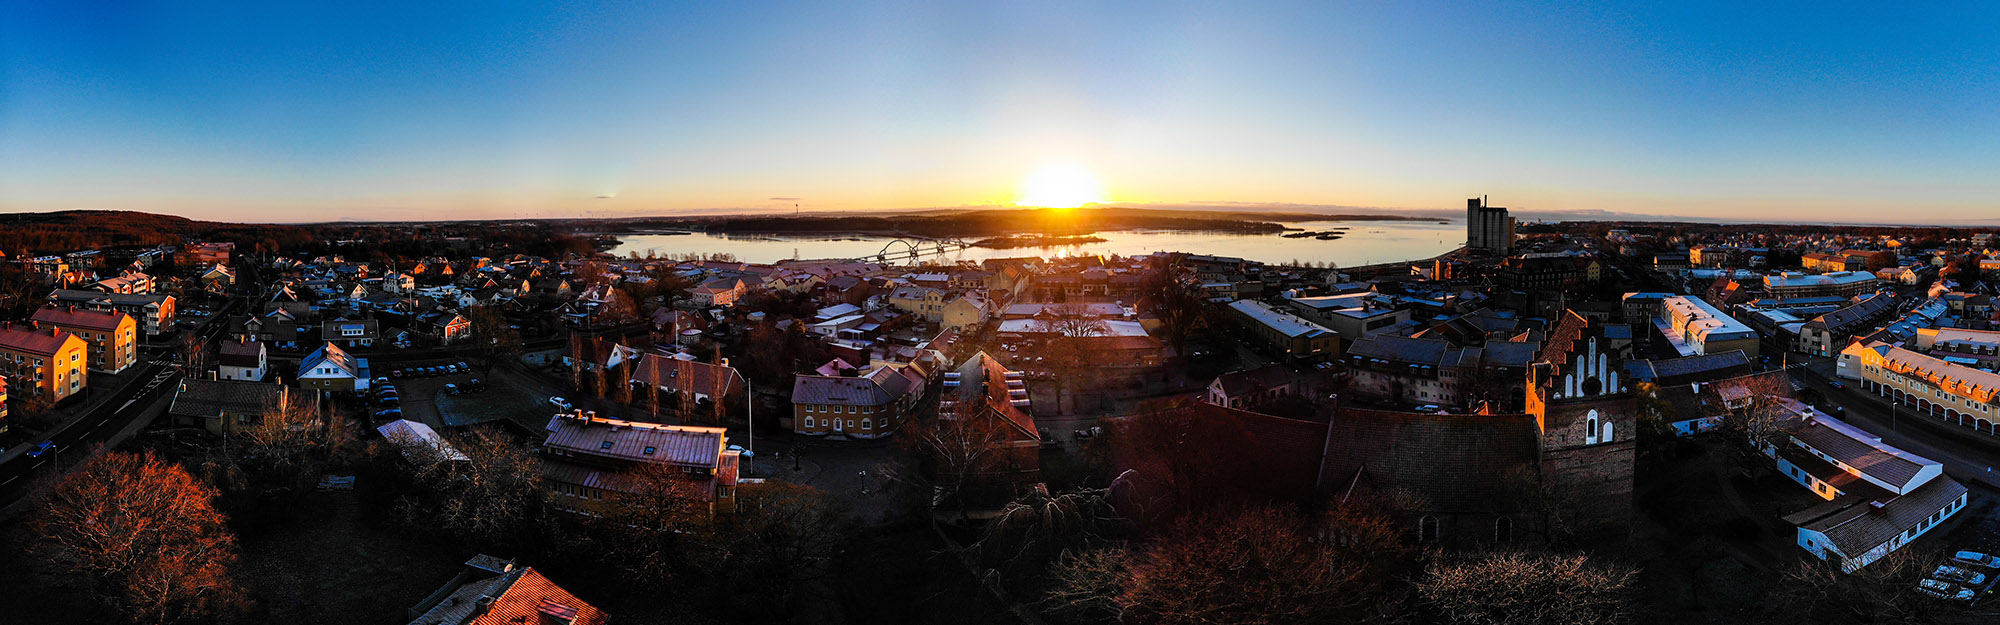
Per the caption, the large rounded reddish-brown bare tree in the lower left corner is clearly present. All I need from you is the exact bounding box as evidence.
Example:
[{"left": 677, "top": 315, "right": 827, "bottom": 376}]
[{"left": 30, "top": 453, "right": 244, "bottom": 623}]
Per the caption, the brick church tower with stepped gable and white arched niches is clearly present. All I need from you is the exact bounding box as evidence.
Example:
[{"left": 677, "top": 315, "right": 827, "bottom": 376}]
[{"left": 1528, "top": 310, "right": 1638, "bottom": 535}]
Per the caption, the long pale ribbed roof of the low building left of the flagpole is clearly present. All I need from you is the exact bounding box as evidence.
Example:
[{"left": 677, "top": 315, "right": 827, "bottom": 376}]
[{"left": 542, "top": 413, "right": 724, "bottom": 469}]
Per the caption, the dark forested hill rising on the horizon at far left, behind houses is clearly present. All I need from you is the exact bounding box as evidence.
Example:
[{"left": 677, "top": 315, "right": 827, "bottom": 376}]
[{"left": 0, "top": 210, "right": 312, "bottom": 256}]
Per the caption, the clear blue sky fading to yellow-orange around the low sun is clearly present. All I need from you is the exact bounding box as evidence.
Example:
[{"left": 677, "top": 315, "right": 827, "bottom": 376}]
[{"left": 0, "top": 0, "right": 2000, "bottom": 224}]
